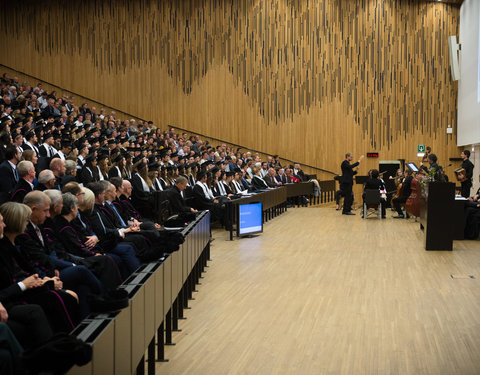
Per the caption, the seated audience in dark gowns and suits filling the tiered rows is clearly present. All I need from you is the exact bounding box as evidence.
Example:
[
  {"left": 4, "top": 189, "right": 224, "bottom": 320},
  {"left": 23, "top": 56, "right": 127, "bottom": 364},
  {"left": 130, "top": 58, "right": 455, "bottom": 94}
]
[{"left": 0, "top": 74, "right": 316, "bottom": 373}]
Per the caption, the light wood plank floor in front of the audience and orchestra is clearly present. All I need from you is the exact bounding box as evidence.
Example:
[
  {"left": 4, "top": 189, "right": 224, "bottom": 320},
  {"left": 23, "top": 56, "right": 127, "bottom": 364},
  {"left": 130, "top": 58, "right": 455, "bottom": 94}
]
[{"left": 157, "top": 208, "right": 480, "bottom": 375}]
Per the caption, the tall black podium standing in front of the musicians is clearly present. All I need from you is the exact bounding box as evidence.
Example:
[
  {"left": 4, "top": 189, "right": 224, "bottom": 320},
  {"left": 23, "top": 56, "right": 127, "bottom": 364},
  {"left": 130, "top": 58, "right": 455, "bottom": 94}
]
[{"left": 420, "top": 182, "right": 455, "bottom": 250}]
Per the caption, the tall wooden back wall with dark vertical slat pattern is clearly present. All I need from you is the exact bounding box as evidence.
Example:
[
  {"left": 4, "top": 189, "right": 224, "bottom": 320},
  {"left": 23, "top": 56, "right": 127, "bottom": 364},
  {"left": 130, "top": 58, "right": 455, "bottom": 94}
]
[{"left": 0, "top": 0, "right": 459, "bottom": 180}]
